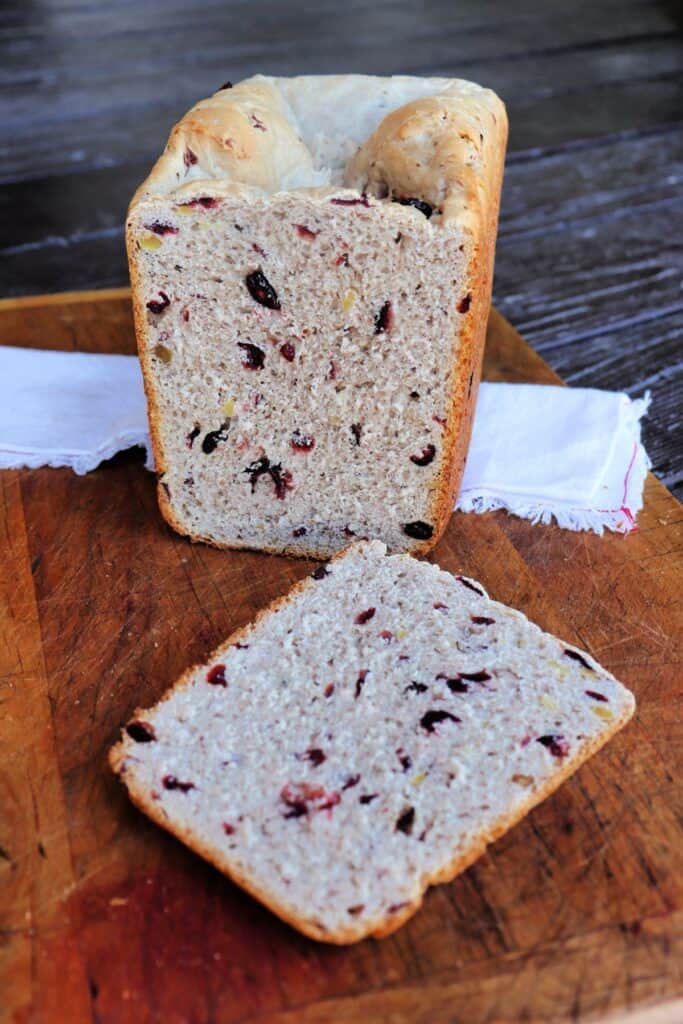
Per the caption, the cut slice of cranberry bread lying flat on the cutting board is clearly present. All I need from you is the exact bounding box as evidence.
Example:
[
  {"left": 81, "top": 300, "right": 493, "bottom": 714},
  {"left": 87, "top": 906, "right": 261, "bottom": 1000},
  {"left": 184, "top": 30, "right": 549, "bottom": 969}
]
[{"left": 110, "top": 541, "right": 635, "bottom": 943}]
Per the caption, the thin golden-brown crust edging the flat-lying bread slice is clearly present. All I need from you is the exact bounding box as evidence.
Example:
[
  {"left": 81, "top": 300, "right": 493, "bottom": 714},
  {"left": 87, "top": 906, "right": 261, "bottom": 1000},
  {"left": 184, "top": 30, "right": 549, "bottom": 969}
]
[{"left": 108, "top": 541, "right": 635, "bottom": 945}]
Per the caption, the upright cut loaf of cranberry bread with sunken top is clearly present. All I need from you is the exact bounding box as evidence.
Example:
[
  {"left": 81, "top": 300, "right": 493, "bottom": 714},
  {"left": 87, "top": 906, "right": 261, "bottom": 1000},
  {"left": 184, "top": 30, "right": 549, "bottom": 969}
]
[{"left": 127, "top": 75, "right": 507, "bottom": 557}]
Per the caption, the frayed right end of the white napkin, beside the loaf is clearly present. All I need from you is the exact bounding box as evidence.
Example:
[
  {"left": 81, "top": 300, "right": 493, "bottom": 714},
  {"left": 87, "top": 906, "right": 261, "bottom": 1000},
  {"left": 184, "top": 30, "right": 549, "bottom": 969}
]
[{"left": 456, "top": 384, "right": 650, "bottom": 534}]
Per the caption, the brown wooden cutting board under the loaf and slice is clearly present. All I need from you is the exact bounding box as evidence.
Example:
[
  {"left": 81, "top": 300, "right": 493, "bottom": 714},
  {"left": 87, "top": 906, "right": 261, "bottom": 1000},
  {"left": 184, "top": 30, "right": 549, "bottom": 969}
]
[{"left": 0, "top": 291, "right": 683, "bottom": 1024}]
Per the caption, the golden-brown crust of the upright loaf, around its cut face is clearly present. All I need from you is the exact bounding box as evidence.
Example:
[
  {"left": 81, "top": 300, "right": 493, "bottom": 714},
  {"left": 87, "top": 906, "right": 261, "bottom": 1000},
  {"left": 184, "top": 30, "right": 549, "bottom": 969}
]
[{"left": 126, "top": 76, "right": 507, "bottom": 559}]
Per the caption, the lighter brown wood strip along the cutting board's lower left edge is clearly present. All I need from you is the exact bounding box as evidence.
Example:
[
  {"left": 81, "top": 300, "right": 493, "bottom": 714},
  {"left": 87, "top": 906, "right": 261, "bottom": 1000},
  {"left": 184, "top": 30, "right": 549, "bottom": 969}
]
[{"left": 0, "top": 471, "right": 90, "bottom": 1020}]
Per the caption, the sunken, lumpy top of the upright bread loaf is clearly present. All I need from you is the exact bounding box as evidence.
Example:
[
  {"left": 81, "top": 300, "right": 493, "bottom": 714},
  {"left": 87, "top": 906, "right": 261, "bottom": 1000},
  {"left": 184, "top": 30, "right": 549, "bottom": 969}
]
[{"left": 133, "top": 75, "right": 507, "bottom": 234}]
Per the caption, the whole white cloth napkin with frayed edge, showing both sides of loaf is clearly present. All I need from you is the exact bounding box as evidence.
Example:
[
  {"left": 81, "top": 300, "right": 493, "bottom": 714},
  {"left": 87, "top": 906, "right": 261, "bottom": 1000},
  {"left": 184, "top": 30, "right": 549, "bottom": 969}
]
[{"left": 0, "top": 347, "right": 649, "bottom": 534}]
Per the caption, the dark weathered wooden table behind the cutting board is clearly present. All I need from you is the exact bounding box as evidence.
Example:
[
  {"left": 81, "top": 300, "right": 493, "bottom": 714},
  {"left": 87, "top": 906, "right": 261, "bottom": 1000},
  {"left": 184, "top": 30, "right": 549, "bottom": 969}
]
[{"left": 0, "top": 0, "right": 683, "bottom": 496}]
